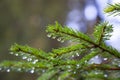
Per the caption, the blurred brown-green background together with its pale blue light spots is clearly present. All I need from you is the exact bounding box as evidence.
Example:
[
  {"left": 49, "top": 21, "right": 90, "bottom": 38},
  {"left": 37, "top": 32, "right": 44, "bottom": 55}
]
[{"left": 0, "top": 0, "right": 116, "bottom": 80}]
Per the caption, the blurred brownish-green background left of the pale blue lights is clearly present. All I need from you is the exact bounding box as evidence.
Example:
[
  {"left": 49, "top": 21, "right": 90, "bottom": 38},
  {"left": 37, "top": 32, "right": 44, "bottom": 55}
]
[{"left": 0, "top": 0, "right": 97, "bottom": 80}]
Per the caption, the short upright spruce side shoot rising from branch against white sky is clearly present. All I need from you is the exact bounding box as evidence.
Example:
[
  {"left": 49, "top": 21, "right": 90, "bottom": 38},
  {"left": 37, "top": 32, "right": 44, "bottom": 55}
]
[{"left": 93, "top": 22, "right": 113, "bottom": 45}]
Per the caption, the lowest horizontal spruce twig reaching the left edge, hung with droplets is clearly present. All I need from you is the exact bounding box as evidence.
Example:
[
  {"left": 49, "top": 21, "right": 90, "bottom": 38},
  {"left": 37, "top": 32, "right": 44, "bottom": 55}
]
[{"left": 0, "top": 61, "right": 51, "bottom": 71}]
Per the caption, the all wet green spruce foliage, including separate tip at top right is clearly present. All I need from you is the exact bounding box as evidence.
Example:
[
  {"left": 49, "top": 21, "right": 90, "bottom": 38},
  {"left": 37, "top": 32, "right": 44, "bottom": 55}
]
[{"left": 0, "top": 4, "right": 120, "bottom": 80}]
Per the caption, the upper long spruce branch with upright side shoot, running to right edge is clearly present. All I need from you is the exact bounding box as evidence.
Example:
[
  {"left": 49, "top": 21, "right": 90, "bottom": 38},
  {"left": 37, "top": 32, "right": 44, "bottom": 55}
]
[{"left": 46, "top": 22, "right": 120, "bottom": 57}]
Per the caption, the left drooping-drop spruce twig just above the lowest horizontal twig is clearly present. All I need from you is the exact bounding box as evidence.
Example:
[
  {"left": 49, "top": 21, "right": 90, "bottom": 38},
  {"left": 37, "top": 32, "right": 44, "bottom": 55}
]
[{"left": 10, "top": 44, "right": 48, "bottom": 60}]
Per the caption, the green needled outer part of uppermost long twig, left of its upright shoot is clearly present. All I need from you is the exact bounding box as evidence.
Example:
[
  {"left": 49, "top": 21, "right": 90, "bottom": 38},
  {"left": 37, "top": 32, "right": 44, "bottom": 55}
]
[{"left": 46, "top": 22, "right": 94, "bottom": 43}]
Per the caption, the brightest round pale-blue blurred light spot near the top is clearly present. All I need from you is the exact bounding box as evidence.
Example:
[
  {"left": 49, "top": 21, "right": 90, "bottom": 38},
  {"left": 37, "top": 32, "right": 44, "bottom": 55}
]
[{"left": 84, "top": 5, "right": 97, "bottom": 20}]
